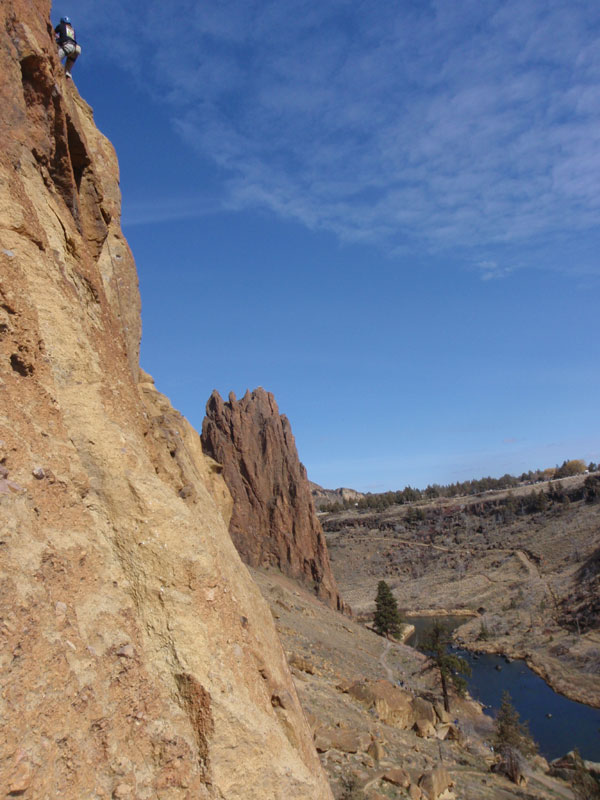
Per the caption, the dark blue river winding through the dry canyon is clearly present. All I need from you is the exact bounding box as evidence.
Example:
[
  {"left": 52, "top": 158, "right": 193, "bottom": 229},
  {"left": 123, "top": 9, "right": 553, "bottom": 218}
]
[{"left": 407, "top": 617, "right": 600, "bottom": 761}]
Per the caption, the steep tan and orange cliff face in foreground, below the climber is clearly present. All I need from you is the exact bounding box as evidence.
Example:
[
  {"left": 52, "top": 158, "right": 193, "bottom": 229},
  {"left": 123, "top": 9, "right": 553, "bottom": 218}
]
[{"left": 0, "top": 0, "right": 331, "bottom": 800}]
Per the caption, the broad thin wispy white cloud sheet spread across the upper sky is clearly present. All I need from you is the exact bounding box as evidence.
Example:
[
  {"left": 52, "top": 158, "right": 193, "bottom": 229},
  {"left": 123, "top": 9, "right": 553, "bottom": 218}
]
[{"left": 68, "top": 0, "right": 600, "bottom": 272}]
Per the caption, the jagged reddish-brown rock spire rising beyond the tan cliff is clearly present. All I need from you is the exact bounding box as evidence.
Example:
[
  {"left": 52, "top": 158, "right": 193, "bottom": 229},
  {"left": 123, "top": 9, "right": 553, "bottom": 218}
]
[{"left": 202, "top": 388, "right": 344, "bottom": 610}]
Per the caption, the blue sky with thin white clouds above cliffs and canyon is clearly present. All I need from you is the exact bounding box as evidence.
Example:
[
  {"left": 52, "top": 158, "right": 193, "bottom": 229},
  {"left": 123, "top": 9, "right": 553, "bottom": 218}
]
[{"left": 53, "top": 0, "right": 600, "bottom": 491}]
